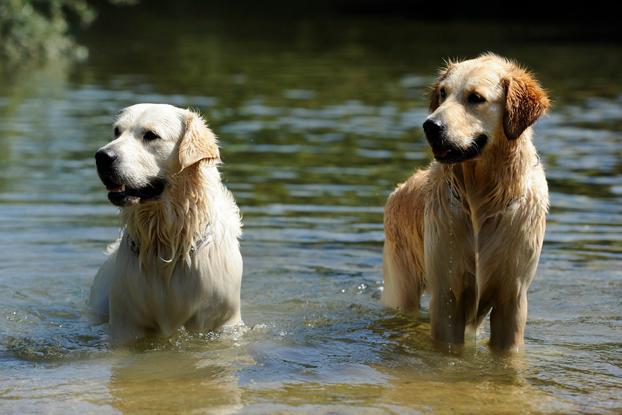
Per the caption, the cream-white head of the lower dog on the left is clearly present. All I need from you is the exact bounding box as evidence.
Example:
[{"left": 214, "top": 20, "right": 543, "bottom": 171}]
[{"left": 95, "top": 104, "right": 220, "bottom": 206}]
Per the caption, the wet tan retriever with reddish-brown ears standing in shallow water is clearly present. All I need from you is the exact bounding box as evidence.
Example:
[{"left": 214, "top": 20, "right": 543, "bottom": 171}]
[{"left": 383, "top": 54, "right": 549, "bottom": 350}]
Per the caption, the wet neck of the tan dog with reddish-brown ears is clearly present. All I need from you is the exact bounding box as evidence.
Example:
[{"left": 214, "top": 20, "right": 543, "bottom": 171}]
[{"left": 443, "top": 128, "right": 540, "bottom": 219}]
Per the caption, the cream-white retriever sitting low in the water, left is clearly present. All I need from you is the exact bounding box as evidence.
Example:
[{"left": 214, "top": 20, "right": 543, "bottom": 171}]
[{"left": 90, "top": 104, "right": 242, "bottom": 344}]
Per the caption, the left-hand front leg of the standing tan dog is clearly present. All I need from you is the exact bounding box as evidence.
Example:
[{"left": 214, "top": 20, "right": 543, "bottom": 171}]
[{"left": 424, "top": 200, "right": 477, "bottom": 344}]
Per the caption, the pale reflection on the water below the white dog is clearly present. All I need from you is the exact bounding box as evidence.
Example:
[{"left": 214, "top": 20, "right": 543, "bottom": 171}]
[{"left": 107, "top": 340, "right": 253, "bottom": 415}]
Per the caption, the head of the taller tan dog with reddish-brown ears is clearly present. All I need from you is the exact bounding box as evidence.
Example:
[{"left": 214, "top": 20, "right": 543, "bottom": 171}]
[{"left": 423, "top": 54, "right": 549, "bottom": 163}]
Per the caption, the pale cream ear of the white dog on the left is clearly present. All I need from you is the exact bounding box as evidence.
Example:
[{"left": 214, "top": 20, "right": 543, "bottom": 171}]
[{"left": 179, "top": 111, "right": 220, "bottom": 172}]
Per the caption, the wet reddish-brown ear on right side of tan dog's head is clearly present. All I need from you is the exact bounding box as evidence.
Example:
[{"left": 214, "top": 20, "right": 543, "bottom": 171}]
[{"left": 501, "top": 68, "right": 550, "bottom": 140}]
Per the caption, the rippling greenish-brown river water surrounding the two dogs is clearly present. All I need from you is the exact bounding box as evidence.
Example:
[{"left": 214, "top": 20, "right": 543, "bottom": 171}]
[{"left": 0, "top": 11, "right": 622, "bottom": 414}]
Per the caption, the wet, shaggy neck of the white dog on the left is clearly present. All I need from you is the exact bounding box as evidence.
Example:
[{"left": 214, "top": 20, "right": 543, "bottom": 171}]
[{"left": 121, "top": 162, "right": 222, "bottom": 269}]
